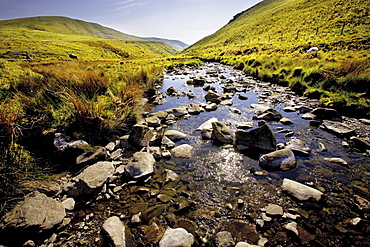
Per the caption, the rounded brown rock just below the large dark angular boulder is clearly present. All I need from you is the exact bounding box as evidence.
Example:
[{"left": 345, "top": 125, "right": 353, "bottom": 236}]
[{"left": 258, "top": 148, "right": 296, "bottom": 171}]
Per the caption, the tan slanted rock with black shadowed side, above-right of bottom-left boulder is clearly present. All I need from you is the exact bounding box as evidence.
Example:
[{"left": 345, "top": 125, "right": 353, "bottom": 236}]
[{"left": 68, "top": 161, "right": 115, "bottom": 197}]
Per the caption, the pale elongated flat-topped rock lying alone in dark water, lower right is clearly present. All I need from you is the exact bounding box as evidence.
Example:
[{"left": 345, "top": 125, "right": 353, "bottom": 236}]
[{"left": 282, "top": 178, "right": 324, "bottom": 201}]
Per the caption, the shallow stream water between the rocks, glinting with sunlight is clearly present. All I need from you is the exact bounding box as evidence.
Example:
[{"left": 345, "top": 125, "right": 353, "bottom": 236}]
[{"left": 146, "top": 64, "right": 370, "bottom": 246}]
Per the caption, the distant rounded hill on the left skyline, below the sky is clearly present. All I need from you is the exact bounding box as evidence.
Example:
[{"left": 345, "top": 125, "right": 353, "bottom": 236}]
[{"left": 0, "top": 16, "right": 188, "bottom": 51}]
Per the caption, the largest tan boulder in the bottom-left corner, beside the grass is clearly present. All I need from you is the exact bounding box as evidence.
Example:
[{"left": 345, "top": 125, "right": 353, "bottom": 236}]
[{"left": 2, "top": 191, "right": 66, "bottom": 232}]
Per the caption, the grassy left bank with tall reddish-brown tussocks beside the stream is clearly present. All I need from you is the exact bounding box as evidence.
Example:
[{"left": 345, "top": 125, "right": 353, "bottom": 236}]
[{"left": 0, "top": 58, "right": 200, "bottom": 205}]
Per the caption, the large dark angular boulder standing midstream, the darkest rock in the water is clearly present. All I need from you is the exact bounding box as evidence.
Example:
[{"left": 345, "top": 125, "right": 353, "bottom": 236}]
[{"left": 235, "top": 124, "right": 276, "bottom": 151}]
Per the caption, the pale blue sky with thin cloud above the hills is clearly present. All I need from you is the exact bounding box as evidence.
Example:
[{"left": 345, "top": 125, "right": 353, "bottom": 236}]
[{"left": 0, "top": 0, "right": 261, "bottom": 45}]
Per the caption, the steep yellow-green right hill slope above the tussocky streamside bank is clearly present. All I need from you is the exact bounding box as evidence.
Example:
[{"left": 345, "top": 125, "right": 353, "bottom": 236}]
[{"left": 186, "top": 0, "right": 370, "bottom": 54}]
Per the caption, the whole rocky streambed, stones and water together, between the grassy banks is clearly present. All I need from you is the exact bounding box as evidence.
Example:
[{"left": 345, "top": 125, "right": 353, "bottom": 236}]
[{"left": 0, "top": 64, "right": 370, "bottom": 247}]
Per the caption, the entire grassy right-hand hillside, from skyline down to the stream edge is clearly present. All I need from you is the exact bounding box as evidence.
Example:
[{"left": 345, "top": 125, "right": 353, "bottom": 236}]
[{"left": 183, "top": 0, "right": 370, "bottom": 116}]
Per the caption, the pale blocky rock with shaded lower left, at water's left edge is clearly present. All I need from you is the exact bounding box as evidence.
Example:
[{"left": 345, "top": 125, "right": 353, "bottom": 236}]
[{"left": 125, "top": 152, "right": 155, "bottom": 179}]
